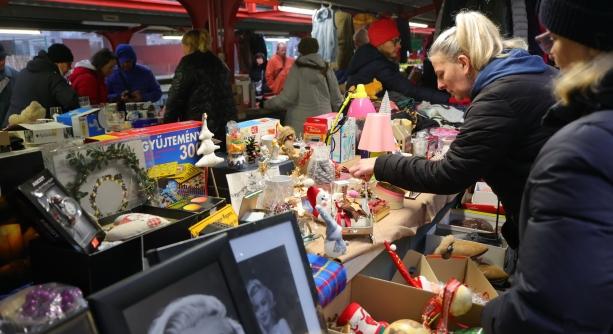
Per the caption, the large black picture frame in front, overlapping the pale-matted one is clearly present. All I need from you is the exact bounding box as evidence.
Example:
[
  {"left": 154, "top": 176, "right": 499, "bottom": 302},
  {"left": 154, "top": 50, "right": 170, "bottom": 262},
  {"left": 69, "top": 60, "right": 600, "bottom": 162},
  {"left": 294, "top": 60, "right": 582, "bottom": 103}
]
[{"left": 88, "top": 234, "right": 260, "bottom": 334}]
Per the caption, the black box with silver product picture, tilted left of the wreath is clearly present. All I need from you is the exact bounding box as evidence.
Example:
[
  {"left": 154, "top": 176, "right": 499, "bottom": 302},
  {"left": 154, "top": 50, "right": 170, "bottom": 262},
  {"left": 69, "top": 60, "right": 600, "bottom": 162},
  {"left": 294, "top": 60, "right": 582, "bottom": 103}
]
[{"left": 17, "top": 169, "right": 105, "bottom": 254}]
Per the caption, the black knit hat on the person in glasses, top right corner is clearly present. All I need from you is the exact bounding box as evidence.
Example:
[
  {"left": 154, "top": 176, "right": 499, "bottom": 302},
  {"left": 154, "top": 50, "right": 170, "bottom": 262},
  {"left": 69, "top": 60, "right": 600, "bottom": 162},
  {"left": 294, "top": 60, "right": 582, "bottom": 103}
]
[{"left": 539, "top": 0, "right": 613, "bottom": 51}]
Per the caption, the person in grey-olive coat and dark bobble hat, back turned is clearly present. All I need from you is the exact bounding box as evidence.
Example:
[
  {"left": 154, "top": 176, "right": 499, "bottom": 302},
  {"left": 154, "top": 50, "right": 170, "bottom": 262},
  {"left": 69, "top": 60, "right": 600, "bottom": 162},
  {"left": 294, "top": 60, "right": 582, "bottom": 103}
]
[{"left": 265, "top": 37, "right": 343, "bottom": 132}]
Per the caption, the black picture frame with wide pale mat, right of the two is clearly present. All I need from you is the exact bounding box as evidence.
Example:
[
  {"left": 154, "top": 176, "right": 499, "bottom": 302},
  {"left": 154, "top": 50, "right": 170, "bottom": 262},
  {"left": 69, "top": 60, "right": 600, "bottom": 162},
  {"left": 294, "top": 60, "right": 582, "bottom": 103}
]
[{"left": 227, "top": 212, "right": 327, "bottom": 334}]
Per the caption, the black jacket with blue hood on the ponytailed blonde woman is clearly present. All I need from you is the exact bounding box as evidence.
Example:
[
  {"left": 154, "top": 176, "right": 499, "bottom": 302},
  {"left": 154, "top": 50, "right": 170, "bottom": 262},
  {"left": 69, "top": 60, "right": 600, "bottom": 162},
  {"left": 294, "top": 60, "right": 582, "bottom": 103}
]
[{"left": 375, "top": 51, "right": 557, "bottom": 248}]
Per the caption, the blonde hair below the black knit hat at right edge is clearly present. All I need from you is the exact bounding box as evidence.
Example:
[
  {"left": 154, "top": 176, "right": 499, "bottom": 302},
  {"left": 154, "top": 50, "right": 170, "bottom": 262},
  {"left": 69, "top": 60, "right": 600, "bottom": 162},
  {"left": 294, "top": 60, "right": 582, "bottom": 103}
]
[{"left": 554, "top": 52, "right": 613, "bottom": 105}]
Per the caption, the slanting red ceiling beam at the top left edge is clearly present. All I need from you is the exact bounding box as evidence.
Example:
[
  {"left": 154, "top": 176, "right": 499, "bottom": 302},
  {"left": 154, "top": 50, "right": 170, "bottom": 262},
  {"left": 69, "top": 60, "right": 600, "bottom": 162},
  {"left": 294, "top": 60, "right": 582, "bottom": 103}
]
[{"left": 41, "top": 0, "right": 185, "bottom": 14}]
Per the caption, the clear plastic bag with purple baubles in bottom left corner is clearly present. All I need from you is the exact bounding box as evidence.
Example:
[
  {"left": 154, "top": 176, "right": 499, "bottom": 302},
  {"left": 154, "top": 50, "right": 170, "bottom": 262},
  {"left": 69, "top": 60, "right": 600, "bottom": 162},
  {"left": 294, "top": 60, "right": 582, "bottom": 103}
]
[{"left": 0, "top": 283, "right": 87, "bottom": 334}]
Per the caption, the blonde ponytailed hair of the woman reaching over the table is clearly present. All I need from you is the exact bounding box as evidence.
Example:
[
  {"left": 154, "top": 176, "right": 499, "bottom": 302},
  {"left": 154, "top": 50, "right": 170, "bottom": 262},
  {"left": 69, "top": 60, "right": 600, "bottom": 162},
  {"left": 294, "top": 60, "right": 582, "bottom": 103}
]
[{"left": 428, "top": 11, "right": 528, "bottom": 72}]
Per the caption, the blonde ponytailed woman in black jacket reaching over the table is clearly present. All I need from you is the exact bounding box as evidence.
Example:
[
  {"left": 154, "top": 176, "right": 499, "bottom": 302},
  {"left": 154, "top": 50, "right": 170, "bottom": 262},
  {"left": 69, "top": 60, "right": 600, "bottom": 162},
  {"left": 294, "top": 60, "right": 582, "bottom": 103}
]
[{"left": 350, "top": 12, "right": 557, "bottom": 250}]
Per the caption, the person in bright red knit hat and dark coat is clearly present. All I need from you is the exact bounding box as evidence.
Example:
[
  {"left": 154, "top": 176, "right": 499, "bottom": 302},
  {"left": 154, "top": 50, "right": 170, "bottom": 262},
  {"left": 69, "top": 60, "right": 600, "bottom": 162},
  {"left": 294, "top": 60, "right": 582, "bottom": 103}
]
[{"left": 347, "top": 19, "right": 449, "bottom": 104}]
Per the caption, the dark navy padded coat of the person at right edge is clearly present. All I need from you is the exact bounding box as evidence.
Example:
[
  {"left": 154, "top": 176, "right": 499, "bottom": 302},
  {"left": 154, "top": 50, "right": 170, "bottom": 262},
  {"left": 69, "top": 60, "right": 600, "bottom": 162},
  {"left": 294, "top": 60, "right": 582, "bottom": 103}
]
[{"left": 481, "top": 71, "right": 613, "bottom": 334}]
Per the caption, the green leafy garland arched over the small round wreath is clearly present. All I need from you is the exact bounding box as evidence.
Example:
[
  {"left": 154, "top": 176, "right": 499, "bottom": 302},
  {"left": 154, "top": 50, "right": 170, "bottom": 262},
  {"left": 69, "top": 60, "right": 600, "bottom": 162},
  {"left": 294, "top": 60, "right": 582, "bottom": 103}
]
[{"left": 66, "top": 143, "right": 155, "bottom": 206}]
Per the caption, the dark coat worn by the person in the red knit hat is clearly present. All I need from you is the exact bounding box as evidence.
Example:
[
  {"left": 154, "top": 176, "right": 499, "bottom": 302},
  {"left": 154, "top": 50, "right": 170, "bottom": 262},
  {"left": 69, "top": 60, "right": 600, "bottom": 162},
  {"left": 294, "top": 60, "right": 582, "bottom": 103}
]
[{"left": 347, "top": 44, "right": 449, "bottom": 104}]
